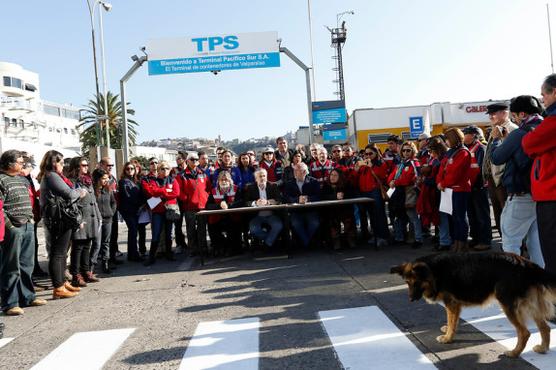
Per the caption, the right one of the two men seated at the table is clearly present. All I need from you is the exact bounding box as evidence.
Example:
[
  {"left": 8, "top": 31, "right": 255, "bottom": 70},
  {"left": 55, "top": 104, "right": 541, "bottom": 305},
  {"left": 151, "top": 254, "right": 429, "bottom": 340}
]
[{"left": 284, "top": 163, "right": 320, "bottom": 247}]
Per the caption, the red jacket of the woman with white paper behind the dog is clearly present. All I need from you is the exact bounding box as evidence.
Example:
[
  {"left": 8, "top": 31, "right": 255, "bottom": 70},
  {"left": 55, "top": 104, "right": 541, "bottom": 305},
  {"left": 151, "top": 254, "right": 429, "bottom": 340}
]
[{"left": 436, "top": 148, "right": 471, "bottom": 193}]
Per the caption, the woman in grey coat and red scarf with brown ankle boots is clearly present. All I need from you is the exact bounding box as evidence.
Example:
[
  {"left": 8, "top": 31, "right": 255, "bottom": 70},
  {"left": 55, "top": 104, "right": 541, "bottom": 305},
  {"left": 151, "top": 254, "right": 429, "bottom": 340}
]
[{"left": 69, "top": 157, "right": 100, "bottom": 287}]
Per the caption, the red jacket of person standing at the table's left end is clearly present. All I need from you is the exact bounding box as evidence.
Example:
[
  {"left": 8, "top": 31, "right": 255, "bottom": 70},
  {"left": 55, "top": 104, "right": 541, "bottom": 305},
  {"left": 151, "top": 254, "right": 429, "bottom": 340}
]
[{"left": 176, "top": 167, "right": 211, "bottom": 211}]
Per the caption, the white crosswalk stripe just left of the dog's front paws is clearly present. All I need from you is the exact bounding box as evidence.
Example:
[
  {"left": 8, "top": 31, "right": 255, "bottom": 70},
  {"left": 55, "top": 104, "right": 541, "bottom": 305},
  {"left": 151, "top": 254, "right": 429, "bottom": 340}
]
[{"left": 319, "top": 306, "right": 435, "bottom": 370}]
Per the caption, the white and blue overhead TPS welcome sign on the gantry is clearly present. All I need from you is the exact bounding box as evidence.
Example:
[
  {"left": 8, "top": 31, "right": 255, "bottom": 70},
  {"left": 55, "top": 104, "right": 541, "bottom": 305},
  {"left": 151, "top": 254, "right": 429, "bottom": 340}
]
[{"left": 147, "top": 32, "right": 280, "bottom": 75}]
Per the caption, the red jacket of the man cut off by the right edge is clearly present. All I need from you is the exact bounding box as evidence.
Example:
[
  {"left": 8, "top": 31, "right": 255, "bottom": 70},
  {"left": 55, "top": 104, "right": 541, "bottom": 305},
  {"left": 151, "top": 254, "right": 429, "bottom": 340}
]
[{"left": 521, "top": 116, "right": 556, "bottom": 202}]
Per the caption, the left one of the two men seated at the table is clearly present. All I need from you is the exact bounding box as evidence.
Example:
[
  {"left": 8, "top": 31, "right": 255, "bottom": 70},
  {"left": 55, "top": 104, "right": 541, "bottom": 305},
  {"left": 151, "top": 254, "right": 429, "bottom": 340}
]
[{"left": 244, "top": 168, "right": 283, "bottom": 247}]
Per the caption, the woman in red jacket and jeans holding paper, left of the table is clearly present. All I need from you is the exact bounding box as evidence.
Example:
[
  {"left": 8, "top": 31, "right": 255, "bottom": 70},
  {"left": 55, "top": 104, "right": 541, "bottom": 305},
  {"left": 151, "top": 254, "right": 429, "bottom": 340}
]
[{"left": 142, "top": 161, "right": 180, "bottom": 266}]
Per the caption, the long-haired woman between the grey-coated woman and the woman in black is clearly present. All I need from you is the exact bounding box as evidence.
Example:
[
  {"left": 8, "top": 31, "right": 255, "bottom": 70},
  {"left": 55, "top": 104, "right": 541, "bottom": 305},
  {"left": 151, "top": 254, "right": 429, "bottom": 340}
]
[{"left": 92, "top": 168, "right": 117, "bottom": 274}]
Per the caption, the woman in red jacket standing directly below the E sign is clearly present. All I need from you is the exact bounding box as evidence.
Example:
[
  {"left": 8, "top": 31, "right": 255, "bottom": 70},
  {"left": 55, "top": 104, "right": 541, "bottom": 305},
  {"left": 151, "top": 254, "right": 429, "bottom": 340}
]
[{"left": 388, "top": 141, "right": 423, "bottom": 248}]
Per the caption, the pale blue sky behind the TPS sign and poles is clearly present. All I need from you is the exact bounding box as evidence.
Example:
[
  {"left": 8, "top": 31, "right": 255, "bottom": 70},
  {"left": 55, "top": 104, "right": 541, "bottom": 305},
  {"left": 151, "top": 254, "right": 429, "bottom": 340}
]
[{"left": 0, "top": 0, "right": 556, "bottom": 141}]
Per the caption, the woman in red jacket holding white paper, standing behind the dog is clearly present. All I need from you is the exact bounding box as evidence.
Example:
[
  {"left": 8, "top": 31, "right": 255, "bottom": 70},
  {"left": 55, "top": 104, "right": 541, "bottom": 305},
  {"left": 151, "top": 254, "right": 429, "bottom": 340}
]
[{"left": 436, "top": 128, "right": 471, "bottom": 252}]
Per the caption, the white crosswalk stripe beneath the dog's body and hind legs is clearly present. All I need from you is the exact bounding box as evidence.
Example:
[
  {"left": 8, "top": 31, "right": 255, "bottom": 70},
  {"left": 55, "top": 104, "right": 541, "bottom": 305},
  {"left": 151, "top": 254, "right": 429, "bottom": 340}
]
[{"left": 461, "top": 304, "right": 556, "bottom": 370}]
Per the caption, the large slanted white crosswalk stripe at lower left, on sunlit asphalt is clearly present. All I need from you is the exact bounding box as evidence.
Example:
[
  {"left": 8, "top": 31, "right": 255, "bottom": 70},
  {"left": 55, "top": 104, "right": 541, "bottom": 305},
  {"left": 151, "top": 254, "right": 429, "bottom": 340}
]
[{"left": 32, "top": 329, "right": 135, "bottom": 370}]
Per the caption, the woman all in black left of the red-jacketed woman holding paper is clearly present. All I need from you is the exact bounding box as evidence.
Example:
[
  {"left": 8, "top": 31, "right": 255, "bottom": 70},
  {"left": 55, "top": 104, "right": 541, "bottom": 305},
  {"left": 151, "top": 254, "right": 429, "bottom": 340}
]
[{"left": 118, "top": 162, "right": 145, "bottom": 262}]
